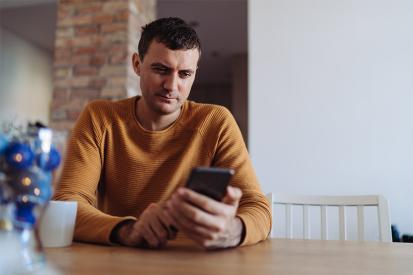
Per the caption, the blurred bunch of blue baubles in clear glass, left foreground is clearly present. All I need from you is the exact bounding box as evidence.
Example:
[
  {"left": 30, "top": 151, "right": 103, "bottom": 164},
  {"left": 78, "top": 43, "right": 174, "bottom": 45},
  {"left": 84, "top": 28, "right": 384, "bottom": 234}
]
[{"left": 0, "top": 125, "right": 61, "bottom": 274}]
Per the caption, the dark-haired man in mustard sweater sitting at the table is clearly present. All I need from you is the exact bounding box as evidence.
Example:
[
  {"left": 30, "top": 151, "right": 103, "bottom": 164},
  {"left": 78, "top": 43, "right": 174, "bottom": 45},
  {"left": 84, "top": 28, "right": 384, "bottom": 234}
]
[{"left": 55, "top": 18, "right": 271, "bottom": 248}]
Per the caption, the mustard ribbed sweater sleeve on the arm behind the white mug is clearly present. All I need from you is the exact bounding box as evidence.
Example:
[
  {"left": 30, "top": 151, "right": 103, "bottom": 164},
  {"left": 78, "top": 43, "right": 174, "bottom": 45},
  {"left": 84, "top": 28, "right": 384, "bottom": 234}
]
[{"left": 54, "top": 102, "right": 134, "bottom": 243}]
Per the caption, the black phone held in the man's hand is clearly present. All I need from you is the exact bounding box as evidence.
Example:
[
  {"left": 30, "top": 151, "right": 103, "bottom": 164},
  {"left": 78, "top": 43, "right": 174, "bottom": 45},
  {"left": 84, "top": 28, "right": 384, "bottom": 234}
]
[{"left": 186, "top": 167, "right": 235, "bottom": 201}]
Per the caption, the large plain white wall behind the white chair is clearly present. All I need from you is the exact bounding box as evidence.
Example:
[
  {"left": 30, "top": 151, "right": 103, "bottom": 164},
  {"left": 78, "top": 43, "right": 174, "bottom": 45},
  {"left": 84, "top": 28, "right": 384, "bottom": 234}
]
[{"left": 248, "top": 0, "right": 413, "bottom": 237}]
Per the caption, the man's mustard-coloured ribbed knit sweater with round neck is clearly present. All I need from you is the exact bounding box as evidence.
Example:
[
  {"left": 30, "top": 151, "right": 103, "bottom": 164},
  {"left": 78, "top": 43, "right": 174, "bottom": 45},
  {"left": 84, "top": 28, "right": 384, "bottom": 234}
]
[{"left": 55, "top": 97, "right": 271, "bottom": 245}]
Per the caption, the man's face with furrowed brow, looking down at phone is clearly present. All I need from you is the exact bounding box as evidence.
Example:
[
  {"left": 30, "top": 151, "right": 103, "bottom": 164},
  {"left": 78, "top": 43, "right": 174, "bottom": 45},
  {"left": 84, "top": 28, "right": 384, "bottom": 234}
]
[{"left": 133, "top": 40, "right": 199, "bottom": 115}]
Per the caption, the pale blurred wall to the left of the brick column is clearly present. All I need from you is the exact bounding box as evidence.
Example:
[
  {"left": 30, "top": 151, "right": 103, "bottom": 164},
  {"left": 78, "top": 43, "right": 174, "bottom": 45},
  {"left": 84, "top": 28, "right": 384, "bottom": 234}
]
[{"left": 0, "top": 29, "right": 53, "bottom": 123}]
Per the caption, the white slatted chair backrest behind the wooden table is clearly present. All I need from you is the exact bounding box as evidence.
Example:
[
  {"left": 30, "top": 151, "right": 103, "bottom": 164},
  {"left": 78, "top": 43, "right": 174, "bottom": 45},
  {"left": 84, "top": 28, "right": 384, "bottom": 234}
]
[{"left": 267, "top": 193, "right": 391, "bottom": 242}]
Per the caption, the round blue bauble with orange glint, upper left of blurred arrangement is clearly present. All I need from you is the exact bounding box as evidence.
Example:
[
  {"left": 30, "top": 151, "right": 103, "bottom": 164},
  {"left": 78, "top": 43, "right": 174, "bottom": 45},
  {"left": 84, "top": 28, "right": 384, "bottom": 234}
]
[{"left": 6, "top": 142, "right": 35, "bottom": 169}]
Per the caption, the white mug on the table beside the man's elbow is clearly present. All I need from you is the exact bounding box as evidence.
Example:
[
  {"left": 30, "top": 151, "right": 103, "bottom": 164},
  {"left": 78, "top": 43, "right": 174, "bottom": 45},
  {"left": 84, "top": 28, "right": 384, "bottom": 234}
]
[{"left": 39, "top": 201, "right": 77, "bottom": 247}]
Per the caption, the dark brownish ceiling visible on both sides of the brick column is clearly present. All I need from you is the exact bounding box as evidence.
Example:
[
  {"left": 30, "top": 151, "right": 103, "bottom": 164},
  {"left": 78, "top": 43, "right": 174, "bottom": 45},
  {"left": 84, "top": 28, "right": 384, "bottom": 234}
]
[{"left": 0, "top": 0, "right": 247, "bottom": 84}]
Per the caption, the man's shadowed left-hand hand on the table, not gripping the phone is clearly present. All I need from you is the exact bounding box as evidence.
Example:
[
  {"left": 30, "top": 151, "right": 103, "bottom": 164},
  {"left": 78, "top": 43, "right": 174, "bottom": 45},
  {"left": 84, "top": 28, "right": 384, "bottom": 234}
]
[{"left": 112, "top": 203, "right": 176, "bottom": 248}]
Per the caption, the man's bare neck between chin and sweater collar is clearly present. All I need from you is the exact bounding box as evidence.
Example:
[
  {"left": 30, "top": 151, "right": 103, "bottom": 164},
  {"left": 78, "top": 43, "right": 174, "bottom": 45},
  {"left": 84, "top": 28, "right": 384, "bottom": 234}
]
[{"left": 136, "top": 98, "right": 181, "bottom": 131}]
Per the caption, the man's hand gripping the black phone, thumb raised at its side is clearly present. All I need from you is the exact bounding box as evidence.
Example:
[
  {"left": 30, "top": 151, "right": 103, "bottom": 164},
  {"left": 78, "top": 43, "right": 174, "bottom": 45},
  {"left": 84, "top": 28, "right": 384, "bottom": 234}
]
[{"left": 166, "top": 187, "right": 244, "bottom": 248}]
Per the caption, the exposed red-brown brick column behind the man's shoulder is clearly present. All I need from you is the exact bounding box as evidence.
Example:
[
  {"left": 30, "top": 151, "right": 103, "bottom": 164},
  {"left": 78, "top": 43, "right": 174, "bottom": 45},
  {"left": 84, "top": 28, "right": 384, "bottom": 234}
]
[{"left": 50, "top": 0, "right": 156, "bottom": 131}]
